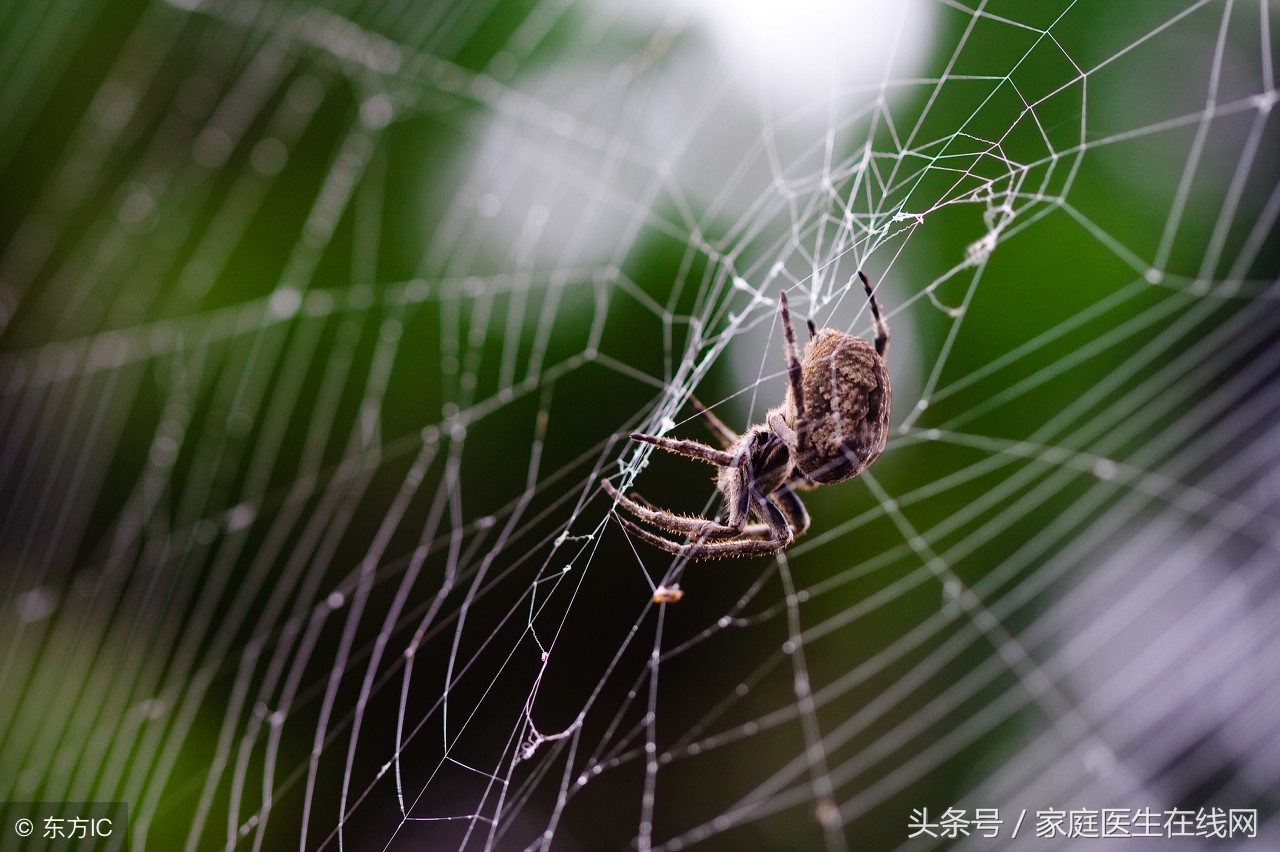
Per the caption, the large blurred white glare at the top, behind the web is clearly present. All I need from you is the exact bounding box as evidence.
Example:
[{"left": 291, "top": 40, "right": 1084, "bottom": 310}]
[{"left": 445, "top": 0, "right": 934, "bottom": 272}]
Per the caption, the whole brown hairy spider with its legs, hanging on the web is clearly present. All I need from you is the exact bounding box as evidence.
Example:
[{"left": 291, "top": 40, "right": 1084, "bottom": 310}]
[{"left": 602, "top": 270, "right": 892, "bottom": 559}]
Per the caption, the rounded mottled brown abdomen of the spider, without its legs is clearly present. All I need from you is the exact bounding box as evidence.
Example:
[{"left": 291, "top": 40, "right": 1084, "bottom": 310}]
[{"left": 786, "top": 329, "right": 892, "bottom": 484}]
